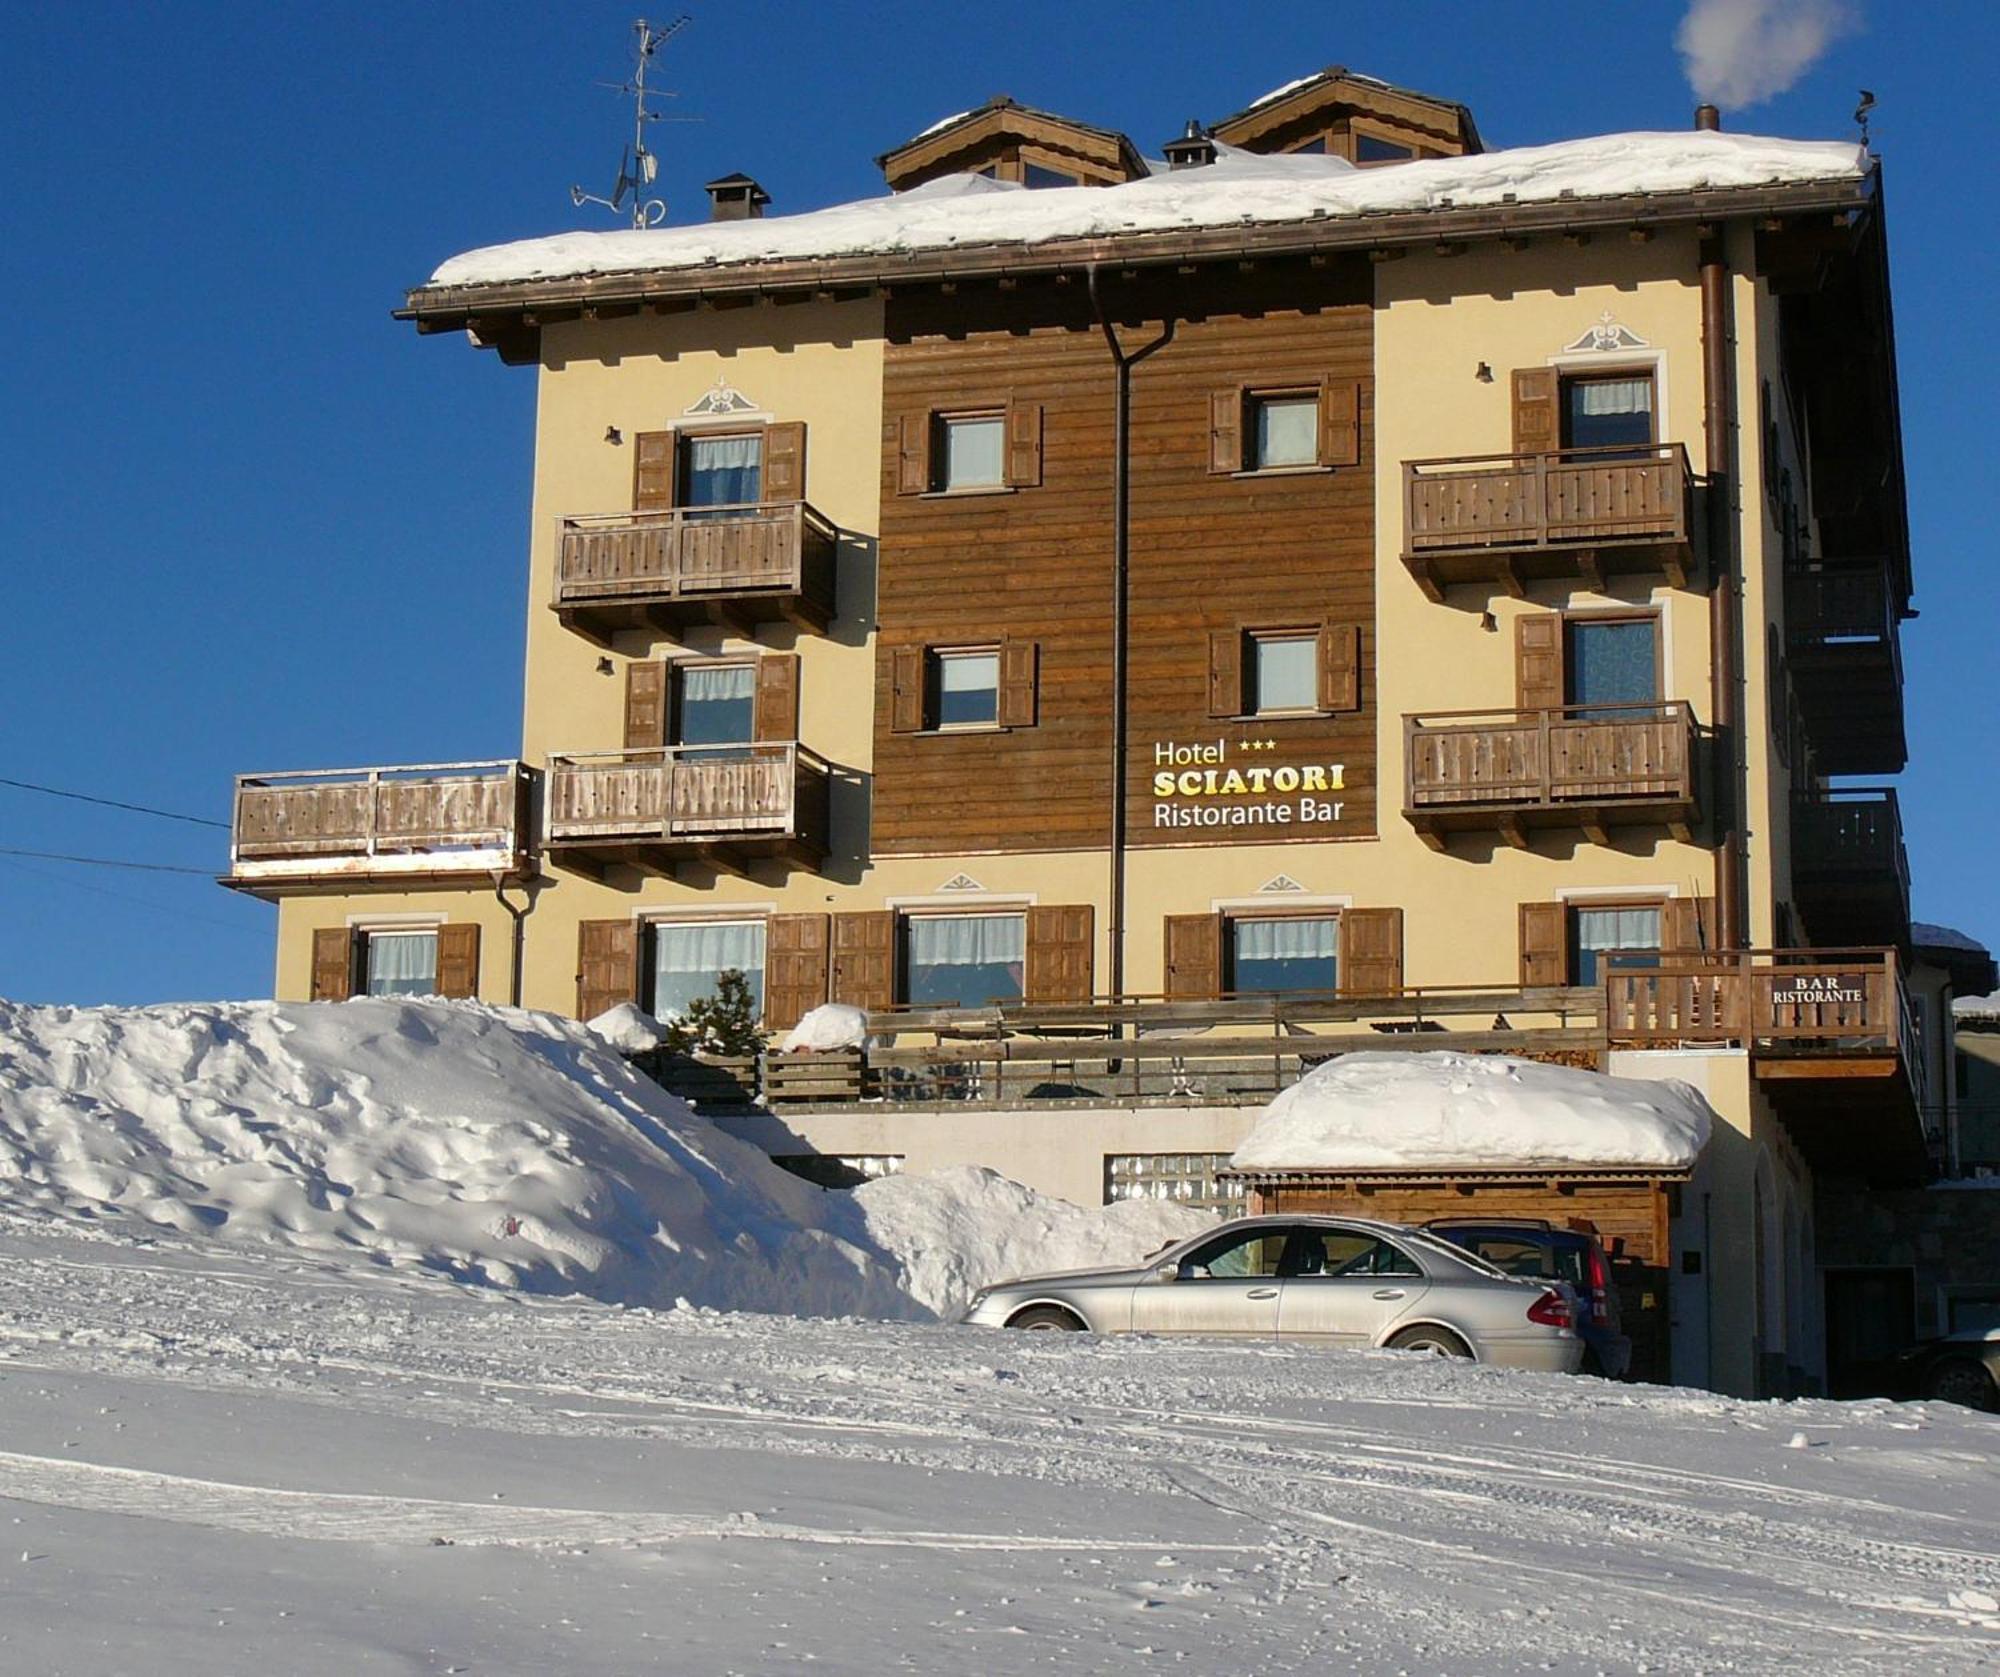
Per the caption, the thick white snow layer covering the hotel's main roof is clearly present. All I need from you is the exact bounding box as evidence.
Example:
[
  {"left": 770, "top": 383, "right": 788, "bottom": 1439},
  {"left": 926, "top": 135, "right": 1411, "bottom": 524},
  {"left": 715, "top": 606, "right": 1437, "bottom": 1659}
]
[{"left": 428, "top": 130, "right": 1868, "bottom": 288}]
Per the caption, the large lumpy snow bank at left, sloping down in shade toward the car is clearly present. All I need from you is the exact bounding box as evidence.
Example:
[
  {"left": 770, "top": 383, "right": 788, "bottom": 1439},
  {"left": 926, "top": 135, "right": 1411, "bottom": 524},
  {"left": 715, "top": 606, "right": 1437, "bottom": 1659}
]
[{"left": 0, "top": 999, "right": 922, "bottom": 1317}]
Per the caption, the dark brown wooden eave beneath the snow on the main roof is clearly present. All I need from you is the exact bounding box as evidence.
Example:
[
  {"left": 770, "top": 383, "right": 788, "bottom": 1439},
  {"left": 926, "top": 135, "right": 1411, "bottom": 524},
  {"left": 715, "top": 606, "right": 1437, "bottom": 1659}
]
[{"left": 394, "top": 170, "right": 1876, "bottom": 366}]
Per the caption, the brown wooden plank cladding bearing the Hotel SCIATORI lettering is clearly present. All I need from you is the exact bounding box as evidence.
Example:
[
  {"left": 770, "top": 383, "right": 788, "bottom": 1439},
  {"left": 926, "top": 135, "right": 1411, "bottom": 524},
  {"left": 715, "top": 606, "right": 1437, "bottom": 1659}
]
[{"left": 872, "top": 270, "right": 1376, "bottom": 855}]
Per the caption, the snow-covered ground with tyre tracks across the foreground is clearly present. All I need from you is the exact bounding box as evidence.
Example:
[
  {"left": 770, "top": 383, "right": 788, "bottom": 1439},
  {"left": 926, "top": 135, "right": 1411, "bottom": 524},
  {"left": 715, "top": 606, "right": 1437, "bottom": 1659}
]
[{"left": 0, "top": 1221, "right": 2000, "bottom": 1677}]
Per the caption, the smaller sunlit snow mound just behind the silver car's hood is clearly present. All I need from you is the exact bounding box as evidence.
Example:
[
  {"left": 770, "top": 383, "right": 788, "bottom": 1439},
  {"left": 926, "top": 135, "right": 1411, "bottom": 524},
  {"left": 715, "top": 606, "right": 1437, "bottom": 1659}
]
[{"left": 854, "top": 1165, "right": 1216, "bottom": 1321}]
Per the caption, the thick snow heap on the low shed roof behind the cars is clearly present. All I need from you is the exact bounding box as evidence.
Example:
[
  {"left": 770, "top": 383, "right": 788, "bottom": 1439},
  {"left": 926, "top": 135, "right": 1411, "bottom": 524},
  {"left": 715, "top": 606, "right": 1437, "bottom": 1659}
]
[{"left": 1230, "top": 1053, "right": 1714, "bottom": 1171}]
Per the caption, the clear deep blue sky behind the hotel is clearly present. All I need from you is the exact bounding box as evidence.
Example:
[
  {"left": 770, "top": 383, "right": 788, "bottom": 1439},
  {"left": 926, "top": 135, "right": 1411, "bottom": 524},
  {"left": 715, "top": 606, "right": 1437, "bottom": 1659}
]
[{"left": 0, "top": 0, "right": 2000, "bottom": 1003}]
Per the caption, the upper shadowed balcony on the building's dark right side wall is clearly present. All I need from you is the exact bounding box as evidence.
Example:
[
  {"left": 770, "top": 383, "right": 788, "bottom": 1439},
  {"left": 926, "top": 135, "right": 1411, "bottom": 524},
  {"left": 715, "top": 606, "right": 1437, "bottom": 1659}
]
[{"left": 1784, "top": 558, "right": 1910, "bottom": 774}]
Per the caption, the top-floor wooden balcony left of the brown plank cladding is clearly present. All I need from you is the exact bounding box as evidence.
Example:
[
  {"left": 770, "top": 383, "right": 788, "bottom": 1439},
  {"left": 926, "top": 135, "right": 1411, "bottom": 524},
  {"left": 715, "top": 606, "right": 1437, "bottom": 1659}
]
[{"left": 552, "top": 500, "right": 838, "bottom": 642}]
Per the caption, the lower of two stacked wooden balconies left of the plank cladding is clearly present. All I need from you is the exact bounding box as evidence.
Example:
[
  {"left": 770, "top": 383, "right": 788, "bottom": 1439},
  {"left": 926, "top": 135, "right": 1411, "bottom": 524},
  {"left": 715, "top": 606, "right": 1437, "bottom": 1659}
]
[{"left": 548, "top": 742, "right": 832, "bottom": 875}]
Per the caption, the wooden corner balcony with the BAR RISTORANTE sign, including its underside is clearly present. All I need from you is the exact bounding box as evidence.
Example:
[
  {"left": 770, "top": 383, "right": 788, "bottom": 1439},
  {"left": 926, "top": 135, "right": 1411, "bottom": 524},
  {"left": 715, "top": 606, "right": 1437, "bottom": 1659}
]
[{"left": 1604, "top": 949, "right": 1932, "bottom": 1181}]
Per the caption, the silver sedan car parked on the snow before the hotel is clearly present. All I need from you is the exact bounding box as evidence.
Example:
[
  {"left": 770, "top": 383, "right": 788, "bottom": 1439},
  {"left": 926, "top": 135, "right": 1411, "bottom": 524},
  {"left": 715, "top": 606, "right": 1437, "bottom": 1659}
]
[{"left": 962, "top": 1217, "right": 1584, "bottom": 1375}]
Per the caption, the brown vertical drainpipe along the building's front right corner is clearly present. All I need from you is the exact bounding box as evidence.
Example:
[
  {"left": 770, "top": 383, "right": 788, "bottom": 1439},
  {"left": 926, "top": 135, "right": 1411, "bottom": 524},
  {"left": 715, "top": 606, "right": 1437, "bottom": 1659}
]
[{"left": 1694, "top": 104, "right": 1746, "bottom": 949}]
